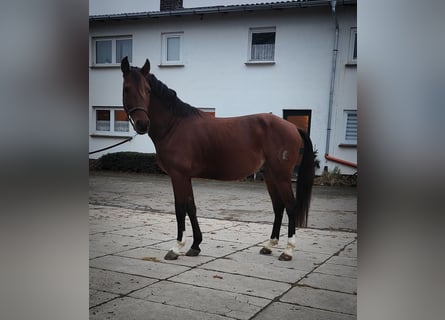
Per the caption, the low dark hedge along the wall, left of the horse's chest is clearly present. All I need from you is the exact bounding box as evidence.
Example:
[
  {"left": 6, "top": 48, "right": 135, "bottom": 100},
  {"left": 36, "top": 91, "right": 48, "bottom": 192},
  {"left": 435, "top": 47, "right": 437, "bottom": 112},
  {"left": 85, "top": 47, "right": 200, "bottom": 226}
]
[{"left": 95, "top": 152, "right": 164, "bottom": 173}]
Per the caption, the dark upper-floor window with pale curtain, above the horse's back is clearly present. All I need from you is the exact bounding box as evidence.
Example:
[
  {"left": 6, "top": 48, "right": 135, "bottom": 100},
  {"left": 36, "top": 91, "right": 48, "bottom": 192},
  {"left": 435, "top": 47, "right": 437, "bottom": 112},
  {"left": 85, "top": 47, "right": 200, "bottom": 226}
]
[{"left": 248, "top": 27, "right": 275, "bottom": 62}]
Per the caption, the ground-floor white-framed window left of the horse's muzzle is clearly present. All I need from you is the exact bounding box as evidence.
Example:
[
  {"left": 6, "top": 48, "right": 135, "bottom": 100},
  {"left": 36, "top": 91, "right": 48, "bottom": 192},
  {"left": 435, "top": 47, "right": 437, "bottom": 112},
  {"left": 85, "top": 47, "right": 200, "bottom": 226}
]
[{"left": 93, "top": 107, "right": 130, "bottom": 135}]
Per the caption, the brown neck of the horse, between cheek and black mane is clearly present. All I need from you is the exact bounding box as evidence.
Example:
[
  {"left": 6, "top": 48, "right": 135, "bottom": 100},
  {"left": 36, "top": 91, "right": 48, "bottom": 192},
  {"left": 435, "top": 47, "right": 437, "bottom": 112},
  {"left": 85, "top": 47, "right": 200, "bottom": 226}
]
[{"left": 148, "top": 95, "right": 178, "bottom": 144}]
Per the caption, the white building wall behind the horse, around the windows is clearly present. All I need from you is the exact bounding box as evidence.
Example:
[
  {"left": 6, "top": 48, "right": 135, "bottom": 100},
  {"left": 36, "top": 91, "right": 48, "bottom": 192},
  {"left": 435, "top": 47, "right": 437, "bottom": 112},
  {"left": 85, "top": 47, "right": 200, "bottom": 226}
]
[{"left": 90, "top": 7, "right": 356, "bottom": 173}]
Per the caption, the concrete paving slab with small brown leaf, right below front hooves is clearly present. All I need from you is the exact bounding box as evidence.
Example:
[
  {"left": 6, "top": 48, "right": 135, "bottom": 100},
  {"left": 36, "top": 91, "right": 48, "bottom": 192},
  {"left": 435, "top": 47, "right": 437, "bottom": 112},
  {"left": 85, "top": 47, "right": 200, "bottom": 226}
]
[{"left": 170, "top": 268, "right": 290, "bottom": 299}]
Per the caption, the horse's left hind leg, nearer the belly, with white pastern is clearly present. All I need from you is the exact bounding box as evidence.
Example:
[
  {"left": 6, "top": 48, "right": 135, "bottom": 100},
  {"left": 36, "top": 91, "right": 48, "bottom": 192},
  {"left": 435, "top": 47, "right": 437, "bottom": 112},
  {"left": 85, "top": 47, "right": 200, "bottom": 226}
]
[{"left": 260, "top": 167, "right": 284, "bottom": 254}]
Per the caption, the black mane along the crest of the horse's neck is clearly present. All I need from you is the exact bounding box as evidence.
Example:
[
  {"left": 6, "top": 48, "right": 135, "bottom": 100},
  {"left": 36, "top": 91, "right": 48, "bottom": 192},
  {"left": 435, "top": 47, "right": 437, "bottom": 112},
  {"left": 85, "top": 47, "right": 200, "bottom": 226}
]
[{"left": 147, "top": 73, "right": 202, "bottom": 117}]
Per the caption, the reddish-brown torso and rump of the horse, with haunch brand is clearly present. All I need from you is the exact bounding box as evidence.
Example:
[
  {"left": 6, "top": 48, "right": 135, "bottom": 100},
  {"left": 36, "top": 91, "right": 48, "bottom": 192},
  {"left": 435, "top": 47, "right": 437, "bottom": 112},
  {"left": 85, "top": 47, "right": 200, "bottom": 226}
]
[{"left": 161, "top": 113, "right": 301, "bottom": 180}]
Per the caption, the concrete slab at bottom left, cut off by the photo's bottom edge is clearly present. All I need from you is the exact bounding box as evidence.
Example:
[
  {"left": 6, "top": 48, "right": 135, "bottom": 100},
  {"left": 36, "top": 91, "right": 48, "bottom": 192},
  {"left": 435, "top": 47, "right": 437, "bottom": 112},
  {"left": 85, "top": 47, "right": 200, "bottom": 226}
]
[{"left": 90, "top": 297, "right": 232, "bottom": 320}]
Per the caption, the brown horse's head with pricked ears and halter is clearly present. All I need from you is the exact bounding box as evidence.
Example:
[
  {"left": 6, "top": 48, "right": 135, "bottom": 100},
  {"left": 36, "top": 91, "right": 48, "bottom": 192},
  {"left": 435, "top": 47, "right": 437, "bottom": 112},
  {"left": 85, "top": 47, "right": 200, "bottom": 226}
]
[{"left": 121, "top": 57, "right": 151, "bottom": 134}]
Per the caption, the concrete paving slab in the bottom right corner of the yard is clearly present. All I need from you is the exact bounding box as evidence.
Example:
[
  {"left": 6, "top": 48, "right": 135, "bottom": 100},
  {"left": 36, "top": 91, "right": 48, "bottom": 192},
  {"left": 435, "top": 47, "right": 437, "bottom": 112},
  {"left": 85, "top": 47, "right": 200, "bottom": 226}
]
[{"left": 280, "top": 286, "right": 357, "bottom": 315}]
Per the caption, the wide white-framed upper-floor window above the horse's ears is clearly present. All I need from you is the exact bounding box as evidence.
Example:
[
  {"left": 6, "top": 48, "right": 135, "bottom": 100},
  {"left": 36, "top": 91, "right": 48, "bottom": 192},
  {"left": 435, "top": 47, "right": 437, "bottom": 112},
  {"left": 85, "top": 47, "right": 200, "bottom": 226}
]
[{"left": 93, "top": 36, "right": 133, "bottom": 66}]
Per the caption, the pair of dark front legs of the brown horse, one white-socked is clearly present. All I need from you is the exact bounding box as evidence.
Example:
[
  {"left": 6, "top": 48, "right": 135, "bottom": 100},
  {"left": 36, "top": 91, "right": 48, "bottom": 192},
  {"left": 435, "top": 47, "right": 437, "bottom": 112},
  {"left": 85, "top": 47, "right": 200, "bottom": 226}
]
[{"left": 164, "top": 176, "right": 202, "bottom": 260}]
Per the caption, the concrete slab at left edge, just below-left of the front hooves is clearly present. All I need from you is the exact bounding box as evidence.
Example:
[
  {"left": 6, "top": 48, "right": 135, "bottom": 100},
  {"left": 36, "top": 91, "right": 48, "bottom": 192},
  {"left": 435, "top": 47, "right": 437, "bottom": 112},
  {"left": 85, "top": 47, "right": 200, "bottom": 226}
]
[{"left": 90, "top": 256, "right": 190, "bottom": 279}]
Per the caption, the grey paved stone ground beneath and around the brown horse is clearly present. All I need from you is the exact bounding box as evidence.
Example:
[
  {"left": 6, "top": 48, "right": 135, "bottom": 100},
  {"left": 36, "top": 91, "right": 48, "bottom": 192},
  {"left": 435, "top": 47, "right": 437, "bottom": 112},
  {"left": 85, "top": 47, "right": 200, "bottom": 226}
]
[{"left": 90, "top": 172, "right": 357, "bottom": 320}]
